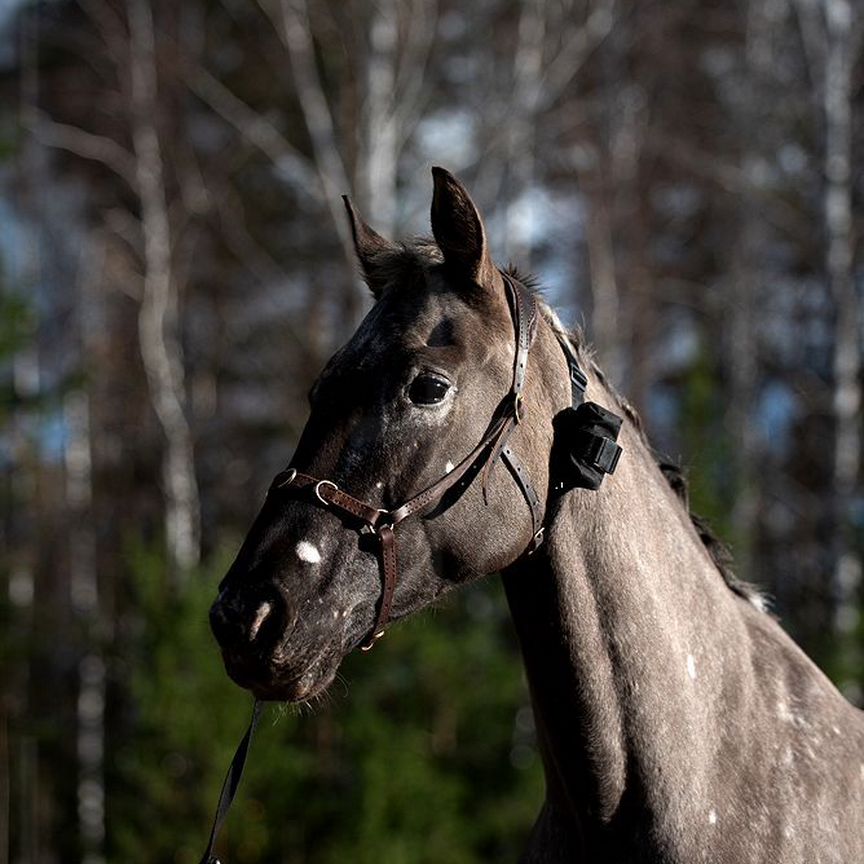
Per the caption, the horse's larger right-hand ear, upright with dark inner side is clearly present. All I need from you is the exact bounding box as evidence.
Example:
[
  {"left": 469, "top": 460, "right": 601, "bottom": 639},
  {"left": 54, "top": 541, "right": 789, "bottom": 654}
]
[{"left": 432, "top": 167, "right": 495, "bottom": 285}]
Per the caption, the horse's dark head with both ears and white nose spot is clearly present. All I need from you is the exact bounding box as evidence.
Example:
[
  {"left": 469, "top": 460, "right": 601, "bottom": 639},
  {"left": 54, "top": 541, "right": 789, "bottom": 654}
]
[{"left": 211, "top": 168, "right": 570, "bottom": 701}]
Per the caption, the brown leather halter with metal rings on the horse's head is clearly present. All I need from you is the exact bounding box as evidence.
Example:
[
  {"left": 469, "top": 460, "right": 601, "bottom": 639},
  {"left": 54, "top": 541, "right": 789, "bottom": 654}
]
[{"left": 270, "top": 273, "right": 543, "bottom": 651}]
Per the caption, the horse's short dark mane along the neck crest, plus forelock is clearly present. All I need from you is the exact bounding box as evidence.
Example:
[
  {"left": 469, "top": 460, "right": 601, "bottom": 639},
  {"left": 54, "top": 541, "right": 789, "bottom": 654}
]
[{"left": 377, "top": 245, "right": 767, "bottom": 611}]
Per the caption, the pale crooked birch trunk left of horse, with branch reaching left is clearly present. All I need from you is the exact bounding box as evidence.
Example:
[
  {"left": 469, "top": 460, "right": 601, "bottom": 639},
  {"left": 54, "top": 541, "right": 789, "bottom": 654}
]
[{"left": 126, "top": 0, "right": 201, "bottom": 574}]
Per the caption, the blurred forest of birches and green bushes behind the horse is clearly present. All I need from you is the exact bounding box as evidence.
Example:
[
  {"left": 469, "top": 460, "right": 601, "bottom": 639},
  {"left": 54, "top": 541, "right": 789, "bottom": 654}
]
[{"left": 0, "top": 0, "right": 864, "bottom": 864}]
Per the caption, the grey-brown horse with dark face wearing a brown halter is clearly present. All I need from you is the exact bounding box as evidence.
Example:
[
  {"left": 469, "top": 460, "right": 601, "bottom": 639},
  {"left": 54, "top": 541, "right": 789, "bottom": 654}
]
[{"left": 211, "top": 168, "right": 864, "bottom": 864}]
